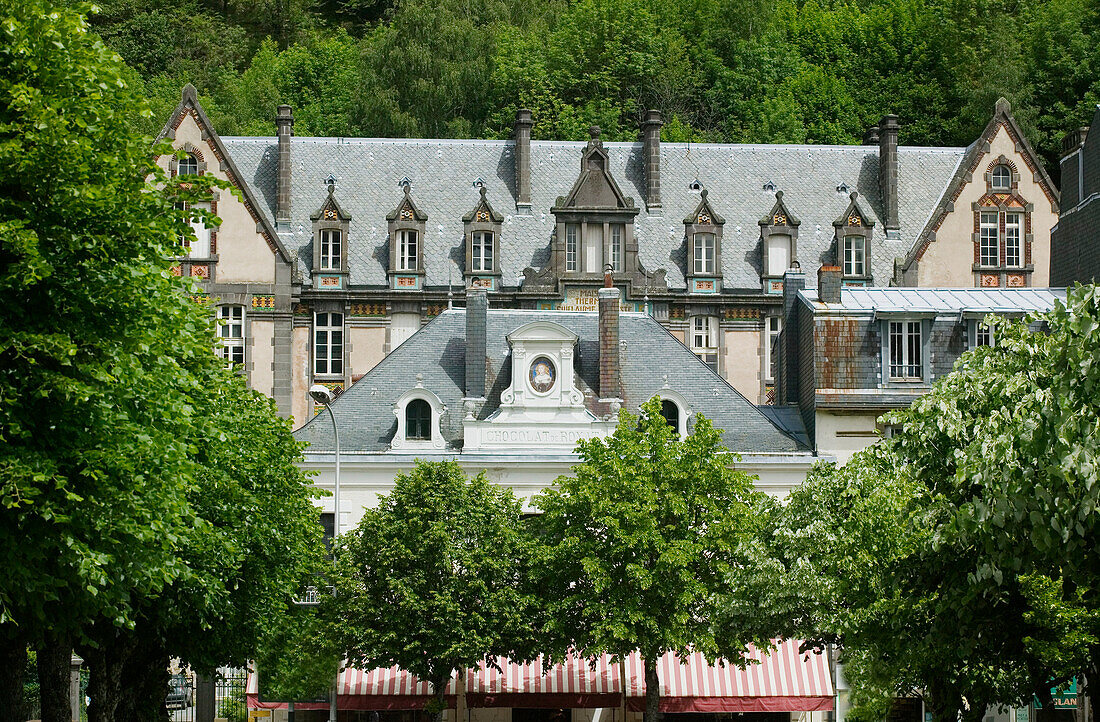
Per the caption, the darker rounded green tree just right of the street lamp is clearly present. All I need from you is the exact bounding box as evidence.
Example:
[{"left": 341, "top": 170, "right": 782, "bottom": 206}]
[{"left": 321, "top": 461, "right": 532, "bottom": 719}]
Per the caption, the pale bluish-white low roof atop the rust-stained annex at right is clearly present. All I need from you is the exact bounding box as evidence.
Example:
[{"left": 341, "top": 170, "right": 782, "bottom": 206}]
[{"left": 799, "top": 287, "right": 1066, "bottom": 314}]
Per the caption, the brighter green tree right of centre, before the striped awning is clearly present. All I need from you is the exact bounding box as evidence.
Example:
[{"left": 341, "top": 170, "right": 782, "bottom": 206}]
[{"left": 535, "top": 398, "right": 769, "bottom": 722}]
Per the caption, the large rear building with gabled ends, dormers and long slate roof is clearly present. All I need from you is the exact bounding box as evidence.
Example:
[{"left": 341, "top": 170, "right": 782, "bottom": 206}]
[{"left": 160, "top": 86, "right": 1057, "bottom": 424}]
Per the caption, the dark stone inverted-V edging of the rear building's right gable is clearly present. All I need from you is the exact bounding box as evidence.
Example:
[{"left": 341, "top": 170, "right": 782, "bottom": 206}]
[{"left": 901, "top": 98, "right": 1059, "bottom": 271}]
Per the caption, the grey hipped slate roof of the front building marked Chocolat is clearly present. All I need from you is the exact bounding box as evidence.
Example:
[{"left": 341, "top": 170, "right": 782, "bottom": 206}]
[{"left": 295, "top": 308, "right": 810, "bottom": 453}]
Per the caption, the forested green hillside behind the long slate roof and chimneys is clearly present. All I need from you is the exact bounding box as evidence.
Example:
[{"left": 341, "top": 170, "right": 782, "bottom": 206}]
[{"left": 91, "top": 0, "right": 1100, "bottom": 176}]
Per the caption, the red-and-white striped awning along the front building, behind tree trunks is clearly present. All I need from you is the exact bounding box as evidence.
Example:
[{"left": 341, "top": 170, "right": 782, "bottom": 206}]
[{"left": 248, "top": 639, "right": 833, "bottom": 712}]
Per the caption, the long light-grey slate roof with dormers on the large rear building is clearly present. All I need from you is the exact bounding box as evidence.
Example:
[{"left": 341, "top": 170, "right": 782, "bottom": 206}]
[{"left": 221, "top": 138, "right": 966, "bottom": 292}]
